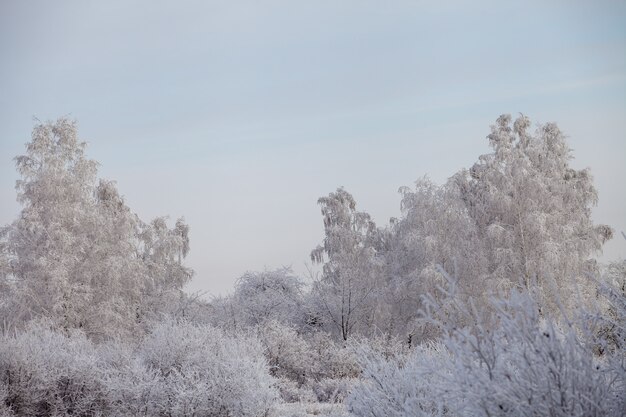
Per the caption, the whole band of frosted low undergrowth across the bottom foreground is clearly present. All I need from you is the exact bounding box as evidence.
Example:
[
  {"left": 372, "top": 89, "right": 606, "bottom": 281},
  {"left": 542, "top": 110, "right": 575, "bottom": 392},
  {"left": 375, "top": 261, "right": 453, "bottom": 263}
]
[{"left": 0, "top": 285, "right": 626, "bottom": 417}]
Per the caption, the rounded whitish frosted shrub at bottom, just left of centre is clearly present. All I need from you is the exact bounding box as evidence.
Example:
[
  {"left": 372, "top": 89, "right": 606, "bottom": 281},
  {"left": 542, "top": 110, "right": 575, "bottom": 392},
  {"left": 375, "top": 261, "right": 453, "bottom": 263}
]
[{"left": 111, "top": 320, "right": 276, "bottom": 417}]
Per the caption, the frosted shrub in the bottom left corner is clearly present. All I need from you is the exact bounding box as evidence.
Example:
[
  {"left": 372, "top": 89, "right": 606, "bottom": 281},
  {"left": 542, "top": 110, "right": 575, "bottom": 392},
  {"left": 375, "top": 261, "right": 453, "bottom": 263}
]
[{"left": 0, "top": 323, "right": 109, "bottom": 416}]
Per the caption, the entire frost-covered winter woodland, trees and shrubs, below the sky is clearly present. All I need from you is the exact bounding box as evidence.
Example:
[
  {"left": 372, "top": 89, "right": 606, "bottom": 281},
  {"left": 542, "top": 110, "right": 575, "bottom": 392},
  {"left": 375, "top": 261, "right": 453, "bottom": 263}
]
[{"left": 0, "top": 115, "right": 626, "bottom": 417}]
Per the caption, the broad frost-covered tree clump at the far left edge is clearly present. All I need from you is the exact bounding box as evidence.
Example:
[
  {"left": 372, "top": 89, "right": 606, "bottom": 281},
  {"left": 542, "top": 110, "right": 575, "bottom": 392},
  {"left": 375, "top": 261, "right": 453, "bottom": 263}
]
[{"left": 0, "top": 119, "right": 191, "bottom": 338}]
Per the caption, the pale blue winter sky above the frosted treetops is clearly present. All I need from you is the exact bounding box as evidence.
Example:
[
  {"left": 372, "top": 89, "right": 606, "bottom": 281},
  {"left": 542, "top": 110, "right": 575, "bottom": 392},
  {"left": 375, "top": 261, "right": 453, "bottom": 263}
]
[{"left": 0, "top": 0, "right": 626, "bottom": 296}]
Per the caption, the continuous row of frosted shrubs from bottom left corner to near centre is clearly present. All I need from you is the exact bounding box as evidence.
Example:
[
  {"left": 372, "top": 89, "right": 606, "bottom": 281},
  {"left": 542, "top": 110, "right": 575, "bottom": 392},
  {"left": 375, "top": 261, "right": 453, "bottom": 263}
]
[{"left": 0, "top": 320, "right": 277, "bottom": 417}]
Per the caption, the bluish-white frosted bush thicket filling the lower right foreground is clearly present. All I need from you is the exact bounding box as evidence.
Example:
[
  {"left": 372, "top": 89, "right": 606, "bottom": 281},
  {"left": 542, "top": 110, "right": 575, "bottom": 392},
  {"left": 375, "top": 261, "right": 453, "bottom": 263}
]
[{"left": 349, "top": 280, "right": 626, "bottom": 416}]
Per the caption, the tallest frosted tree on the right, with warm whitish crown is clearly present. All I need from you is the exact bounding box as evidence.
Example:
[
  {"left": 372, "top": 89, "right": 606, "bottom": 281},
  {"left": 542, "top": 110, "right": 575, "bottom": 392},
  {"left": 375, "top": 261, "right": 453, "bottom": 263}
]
[{"left": 452, "top": 115, "right": 612, "bottom": 307}]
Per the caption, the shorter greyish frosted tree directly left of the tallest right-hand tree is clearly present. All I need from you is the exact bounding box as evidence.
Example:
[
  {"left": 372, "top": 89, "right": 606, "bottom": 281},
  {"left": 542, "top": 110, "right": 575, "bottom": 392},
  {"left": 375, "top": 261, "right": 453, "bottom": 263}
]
[{"left": 382, "top": 178, "right": 488, "bottom": 343}]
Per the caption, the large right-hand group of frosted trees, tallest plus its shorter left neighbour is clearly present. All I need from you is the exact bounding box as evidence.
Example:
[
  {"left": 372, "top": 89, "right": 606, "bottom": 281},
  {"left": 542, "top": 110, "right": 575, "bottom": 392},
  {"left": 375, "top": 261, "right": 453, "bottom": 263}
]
[{"left": 385, "top": 115, "right": 612, "bottom": 321}]
